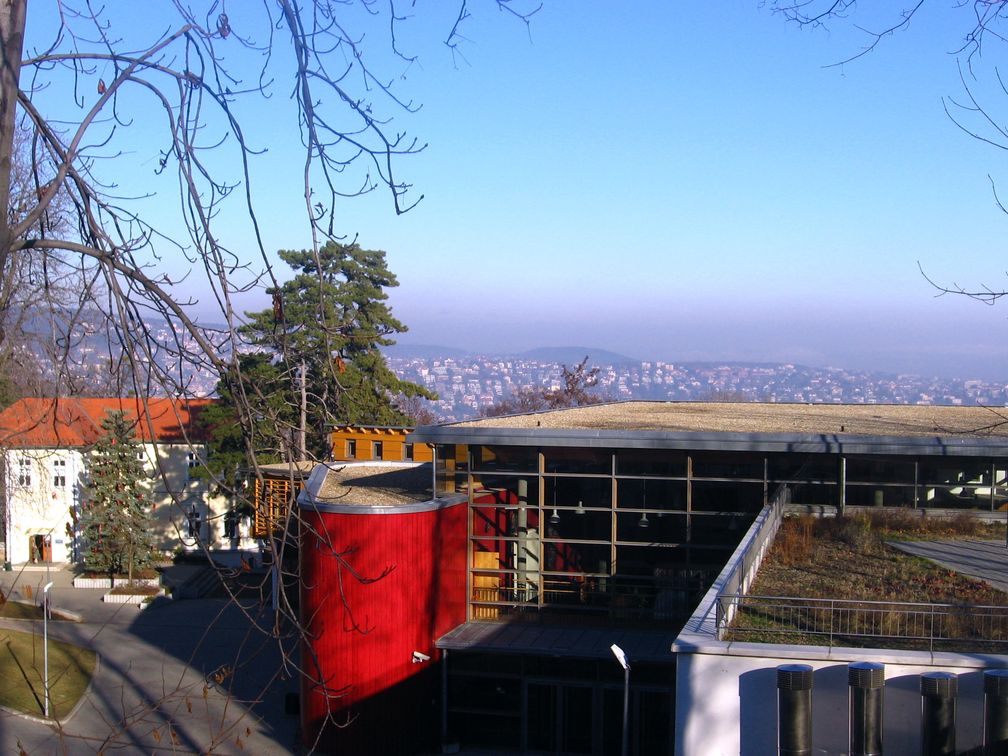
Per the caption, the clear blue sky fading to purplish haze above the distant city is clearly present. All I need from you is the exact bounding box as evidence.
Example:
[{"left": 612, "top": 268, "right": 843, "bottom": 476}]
[{"left": 25, "top": 0, "right": 1008, "bottom": 380}]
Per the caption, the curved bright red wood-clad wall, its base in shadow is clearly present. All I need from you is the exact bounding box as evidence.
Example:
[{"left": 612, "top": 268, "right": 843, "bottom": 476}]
[{"left": 300, "top": 502, "right": 467, "bottom": 754}]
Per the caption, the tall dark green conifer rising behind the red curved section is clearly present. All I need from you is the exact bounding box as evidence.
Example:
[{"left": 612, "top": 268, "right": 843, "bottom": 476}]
[{"left": 238, "top": 241, "right": 435, "bottom": 459}]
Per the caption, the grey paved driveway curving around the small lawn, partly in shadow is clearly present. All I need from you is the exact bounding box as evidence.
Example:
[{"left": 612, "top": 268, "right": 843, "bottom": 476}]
[{"left": 0, "top": 570, "right": 298, "bottom": 756}]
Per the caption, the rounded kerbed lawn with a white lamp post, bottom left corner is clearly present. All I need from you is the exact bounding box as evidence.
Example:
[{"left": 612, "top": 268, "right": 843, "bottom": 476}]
[{"left": 0, "top": 630, "right": 96, "bottom": 719}]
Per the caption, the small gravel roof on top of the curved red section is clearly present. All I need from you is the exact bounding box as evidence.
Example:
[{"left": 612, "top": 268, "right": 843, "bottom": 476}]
[{"left": 317, "top": 464, "right": 433, "bottom": 507}]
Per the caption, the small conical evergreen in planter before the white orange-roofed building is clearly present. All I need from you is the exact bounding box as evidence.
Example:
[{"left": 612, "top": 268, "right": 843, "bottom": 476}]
[{"left": 81, "top": 412, "right": 154, "bottom": 582}]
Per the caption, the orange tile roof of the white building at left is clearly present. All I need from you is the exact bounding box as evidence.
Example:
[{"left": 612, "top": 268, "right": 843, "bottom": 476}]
[{"left": 0, "top": 397, "right": 216, "bottom": 448}]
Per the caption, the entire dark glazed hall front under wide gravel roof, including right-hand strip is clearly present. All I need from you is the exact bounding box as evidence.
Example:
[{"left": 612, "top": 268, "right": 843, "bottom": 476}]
[{"left": 435, "top": 445, "right": 1008, "bottom": 628}]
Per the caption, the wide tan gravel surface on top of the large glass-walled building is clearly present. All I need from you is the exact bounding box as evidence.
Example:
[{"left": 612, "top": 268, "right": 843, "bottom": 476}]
[{"left": 446, "top": 401, "right": 1008, "bottom": 437}]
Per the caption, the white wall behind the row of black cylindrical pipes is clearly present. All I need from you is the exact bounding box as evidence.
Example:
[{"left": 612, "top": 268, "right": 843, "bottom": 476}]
[{"left": 675, "top": 643, "right": 995, "bottom": 756}]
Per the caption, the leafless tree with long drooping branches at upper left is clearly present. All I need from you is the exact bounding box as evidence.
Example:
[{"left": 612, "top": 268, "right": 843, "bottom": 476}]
[{"left": 0, "top": 0, "right": 538, "bottom": 748}]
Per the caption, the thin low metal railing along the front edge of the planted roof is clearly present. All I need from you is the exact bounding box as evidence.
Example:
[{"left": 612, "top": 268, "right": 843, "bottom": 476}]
[{"left": 717, "top": 594, "right": 1008, "bottom": 650}]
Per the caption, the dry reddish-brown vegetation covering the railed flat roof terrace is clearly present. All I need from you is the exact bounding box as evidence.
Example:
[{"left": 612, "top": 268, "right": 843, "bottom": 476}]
[{"left": 727, "top": 510, "right": 1008, "bottom": 652}]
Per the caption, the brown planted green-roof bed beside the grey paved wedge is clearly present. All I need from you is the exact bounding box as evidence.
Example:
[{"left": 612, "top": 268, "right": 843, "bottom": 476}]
[{"left": 730, "top": 510, "right": 1008, "bottom": 647}]
